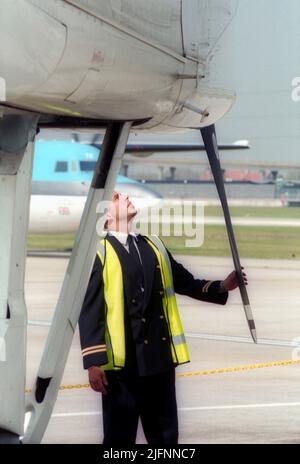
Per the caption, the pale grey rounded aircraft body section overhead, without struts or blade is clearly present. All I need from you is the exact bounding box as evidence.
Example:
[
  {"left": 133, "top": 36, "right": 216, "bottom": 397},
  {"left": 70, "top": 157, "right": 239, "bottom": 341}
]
[{"left": 0, "top": 0, "right": 236, "bottom": 131}]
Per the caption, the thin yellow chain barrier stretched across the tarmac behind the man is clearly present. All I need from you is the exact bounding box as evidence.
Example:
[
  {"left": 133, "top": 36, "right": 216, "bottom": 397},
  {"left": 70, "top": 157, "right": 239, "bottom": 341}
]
[{"left": 25, "top": 359, "right": 300, "bottom": 393}]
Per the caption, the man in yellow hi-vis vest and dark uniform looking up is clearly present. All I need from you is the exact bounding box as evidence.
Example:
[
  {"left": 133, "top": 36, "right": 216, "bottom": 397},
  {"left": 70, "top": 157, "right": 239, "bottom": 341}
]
[{"left": 79, "top": 192, "right": 247, "bottom": 446}]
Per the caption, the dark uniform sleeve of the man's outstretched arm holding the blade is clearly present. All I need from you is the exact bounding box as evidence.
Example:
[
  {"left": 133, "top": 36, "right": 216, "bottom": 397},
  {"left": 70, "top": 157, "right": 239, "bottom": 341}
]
[{"left": 167, "top": 250, "right": 228, "bottom": 305}]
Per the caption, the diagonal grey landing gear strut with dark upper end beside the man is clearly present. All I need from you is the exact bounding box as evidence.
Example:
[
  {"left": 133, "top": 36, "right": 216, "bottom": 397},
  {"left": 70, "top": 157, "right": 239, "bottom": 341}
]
[{"left": 22, "top": 122, "right": 132, "bottom": 443}]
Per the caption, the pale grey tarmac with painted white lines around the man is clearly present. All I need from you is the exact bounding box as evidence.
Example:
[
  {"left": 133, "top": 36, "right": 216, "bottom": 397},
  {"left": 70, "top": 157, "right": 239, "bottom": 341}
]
[{"left": 25, "top": 256, "right": 300, "bottom": 444}]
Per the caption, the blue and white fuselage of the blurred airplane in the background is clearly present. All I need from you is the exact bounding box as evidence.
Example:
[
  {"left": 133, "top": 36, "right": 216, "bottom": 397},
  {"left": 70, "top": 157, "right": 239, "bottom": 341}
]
[{"left": 29, "top": 140, "right": 161, "bottom": 234}]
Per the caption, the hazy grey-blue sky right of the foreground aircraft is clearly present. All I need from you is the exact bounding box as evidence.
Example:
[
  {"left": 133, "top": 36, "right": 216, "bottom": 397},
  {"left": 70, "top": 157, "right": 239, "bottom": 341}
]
[{"left": 217, "top": 0, "right": 300, "bottom": 166}]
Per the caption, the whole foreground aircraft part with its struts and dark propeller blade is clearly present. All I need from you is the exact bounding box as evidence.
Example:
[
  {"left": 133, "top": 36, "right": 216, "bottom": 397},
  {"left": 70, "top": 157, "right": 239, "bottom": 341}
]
[{"left": 0, "top": 0, "right": 256, "bottom": 444}]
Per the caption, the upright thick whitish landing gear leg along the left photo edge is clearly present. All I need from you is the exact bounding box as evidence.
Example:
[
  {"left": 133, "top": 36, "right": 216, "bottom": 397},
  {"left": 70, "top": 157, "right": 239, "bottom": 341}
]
[{"left": 0, "top": 109, "right": 39, "bottom": 444}]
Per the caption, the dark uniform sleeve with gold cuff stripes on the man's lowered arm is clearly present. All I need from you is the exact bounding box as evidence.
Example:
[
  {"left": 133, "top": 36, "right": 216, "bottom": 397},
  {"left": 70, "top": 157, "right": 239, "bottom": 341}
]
[{"left": 79, "top": 255, "right": 108, "bottom": 369}]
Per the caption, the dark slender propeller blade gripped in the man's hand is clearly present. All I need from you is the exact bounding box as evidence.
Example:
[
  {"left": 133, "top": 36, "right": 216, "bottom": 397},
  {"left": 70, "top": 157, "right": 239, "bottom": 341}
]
[{"left": 201, "top": 125, "right": 257, "bottom": 343}]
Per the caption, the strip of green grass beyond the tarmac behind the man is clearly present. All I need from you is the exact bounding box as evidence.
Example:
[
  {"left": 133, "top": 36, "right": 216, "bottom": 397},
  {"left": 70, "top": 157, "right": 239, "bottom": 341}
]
[{"left": 28, "top": 226, "right": 300, "bottom": 260}]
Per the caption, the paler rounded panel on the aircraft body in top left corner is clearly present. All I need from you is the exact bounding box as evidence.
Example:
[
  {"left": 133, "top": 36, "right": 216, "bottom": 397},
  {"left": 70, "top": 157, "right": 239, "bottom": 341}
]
[{"left": 0, "top": 0, "right": 67, "bottom": 100}]
